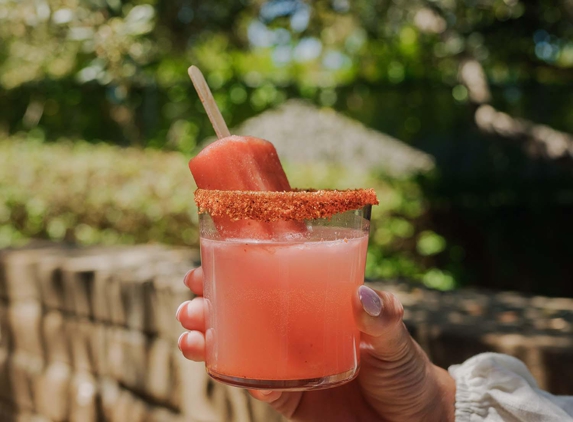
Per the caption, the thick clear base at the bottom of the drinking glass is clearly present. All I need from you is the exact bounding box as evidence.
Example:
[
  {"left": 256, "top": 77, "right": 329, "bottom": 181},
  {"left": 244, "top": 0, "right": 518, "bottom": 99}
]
[{"left": 207, "top": 366, "right": 360, "bottom": 391}]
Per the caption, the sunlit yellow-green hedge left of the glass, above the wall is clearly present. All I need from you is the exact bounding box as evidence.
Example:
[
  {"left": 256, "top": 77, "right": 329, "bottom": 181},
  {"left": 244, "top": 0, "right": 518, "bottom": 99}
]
[{"left": 0, "top": 135, "right": 197, "bottom": 246}]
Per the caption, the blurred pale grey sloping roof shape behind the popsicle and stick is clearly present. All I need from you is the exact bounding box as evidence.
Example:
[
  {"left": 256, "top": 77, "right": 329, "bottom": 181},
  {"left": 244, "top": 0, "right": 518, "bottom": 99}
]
[{"left": 225, "top": 100, "right": 434, "bottom": 176}]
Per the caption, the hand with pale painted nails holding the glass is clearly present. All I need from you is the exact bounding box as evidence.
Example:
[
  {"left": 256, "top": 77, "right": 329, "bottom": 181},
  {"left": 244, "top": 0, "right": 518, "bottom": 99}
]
[{"left": 176, "top": 268, "right": 455, "bottom": 422}]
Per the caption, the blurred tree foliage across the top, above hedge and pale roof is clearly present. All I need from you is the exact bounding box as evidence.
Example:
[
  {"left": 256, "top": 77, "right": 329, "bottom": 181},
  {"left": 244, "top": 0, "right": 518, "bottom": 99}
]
[{"left": 0, "top": 0, "right": 573, "bottom": 145}]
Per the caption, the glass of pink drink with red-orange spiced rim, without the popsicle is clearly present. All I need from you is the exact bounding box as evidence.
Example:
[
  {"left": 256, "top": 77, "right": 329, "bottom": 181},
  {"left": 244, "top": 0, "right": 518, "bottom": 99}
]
[{"left": 195, "top": 190, "right": 375, "bottom": 390}]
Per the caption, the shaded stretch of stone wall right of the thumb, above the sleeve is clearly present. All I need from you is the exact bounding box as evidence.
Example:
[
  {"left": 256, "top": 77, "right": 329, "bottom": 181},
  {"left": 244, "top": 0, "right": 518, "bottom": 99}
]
[{"left": 373, "top": 283, "right": 573, "bottom": 395}]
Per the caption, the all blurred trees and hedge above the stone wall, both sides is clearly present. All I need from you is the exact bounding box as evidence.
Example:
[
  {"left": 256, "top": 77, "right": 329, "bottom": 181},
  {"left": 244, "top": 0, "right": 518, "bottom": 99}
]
[{"left": 0, "top": 0, "right": 573, "bottom": 295}]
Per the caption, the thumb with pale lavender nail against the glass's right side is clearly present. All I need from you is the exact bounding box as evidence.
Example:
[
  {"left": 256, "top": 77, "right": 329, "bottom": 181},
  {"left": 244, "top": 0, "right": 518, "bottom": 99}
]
[{"left": 353, "top": 285, "right": 414, "bottom": 362}]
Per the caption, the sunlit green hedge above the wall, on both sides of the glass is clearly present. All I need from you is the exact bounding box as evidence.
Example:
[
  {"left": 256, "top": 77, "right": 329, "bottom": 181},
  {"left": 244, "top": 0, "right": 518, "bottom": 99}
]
[{"left": 0, "top": 136, "right": 455, "bottom": 289}]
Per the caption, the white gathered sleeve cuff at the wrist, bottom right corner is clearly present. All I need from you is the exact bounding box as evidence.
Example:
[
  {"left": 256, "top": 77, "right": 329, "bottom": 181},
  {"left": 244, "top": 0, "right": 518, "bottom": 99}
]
[{"left": 449, "top": 353, "right": 573, "bottom": 422}]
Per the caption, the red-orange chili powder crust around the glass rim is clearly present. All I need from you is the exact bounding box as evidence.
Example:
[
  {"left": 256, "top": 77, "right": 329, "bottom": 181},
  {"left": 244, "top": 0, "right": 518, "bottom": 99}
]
[{"left": 195, "top": 189, "right": 379, "bottom": 222}]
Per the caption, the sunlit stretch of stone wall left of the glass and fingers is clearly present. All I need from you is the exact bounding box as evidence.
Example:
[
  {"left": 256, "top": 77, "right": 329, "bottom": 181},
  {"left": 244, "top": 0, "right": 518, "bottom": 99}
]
[{"left": 0, "top": 245, "right": 280, "bottom": 422}]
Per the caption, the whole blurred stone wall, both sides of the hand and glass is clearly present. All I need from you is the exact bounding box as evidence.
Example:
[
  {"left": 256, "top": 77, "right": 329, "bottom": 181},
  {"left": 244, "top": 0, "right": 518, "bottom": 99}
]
[{"left": 0, "top": 244, "right": 573, "bottom": 422}]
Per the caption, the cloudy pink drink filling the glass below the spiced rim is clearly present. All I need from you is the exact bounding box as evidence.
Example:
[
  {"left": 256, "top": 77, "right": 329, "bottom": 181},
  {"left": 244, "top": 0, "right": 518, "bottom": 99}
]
[{"left": 201, "top": 223, "right": 368, "bottom": 389}]
